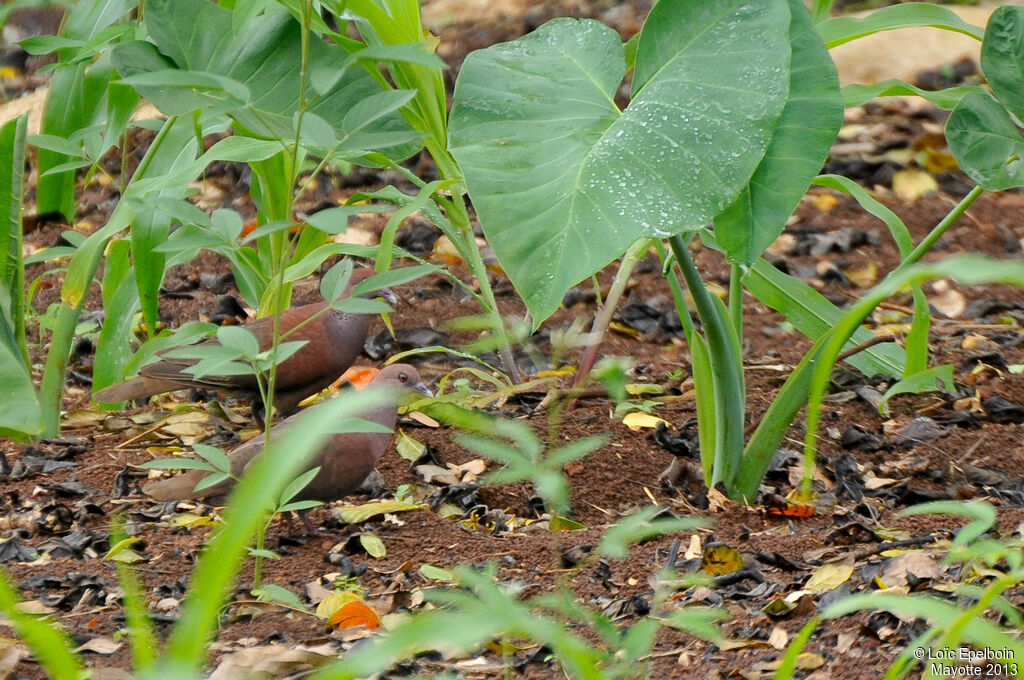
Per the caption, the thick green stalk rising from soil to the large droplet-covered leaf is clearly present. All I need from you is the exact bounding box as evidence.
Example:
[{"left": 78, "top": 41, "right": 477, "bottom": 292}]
[{"left": 669, "top": 235, "right": 745, "bottom": 497}]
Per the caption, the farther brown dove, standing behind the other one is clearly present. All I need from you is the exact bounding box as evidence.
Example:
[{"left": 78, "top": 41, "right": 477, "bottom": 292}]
[{"left": 92, "top": 269, "right": 395, "bottom": 413}]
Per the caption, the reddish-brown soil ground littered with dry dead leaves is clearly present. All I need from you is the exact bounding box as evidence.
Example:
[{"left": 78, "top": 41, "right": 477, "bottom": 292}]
[{"left": 0, "top": 2, "right": 1024, "bottom": 680}]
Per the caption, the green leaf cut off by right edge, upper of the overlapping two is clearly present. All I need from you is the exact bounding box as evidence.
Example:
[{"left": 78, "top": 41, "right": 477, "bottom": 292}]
[{"left": 981, "top": 7, "right": 1024, "bottom": 120}]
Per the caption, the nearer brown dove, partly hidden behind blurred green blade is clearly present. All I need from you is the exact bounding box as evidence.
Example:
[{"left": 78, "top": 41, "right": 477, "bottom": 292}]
[{"left": 142, "top": 364, "right": 432, "bottom": 520}]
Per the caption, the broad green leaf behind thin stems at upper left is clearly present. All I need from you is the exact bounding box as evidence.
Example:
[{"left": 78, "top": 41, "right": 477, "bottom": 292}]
[{"left": 112, "top": 0, "right": 420, "bottom": 160}]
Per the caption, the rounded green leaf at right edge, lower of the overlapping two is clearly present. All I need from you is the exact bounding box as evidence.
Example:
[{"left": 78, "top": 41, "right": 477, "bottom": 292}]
[{"left": 946, "top": 92, "right": 1024, "bottom": 192}]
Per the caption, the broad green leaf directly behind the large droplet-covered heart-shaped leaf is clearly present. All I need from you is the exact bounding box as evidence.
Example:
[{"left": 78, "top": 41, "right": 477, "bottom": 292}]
[{"left": 715, "top": 0, "right": 843, "bottom": 266}]
